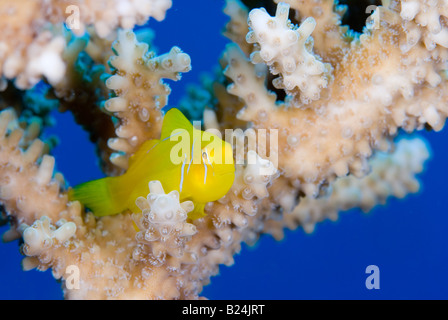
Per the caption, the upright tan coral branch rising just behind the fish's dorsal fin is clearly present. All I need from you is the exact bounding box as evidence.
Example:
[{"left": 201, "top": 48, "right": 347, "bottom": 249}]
[{"left": 104, "top": 31, "right": 191, "bottom": 169}]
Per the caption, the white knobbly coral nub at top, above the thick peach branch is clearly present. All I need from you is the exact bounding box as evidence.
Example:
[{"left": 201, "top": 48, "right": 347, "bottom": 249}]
[{"left": 246, "top": 3, "right": 331, "bottom": 104}]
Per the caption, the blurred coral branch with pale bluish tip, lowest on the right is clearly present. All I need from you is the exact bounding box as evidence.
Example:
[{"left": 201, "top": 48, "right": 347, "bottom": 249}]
[{"left": 265, "top": 139, "right": 429, "bottom": 240}]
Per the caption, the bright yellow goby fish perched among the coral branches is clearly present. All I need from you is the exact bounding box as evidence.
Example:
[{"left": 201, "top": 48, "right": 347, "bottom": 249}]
[{"left": 69, "top": 109, "right": 235, "bottom": 219}]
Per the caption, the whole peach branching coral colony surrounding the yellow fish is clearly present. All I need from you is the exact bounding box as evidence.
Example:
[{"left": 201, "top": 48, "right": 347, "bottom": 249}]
[{"left": 0, "top": 0, "right": 448, "bottom": 299}]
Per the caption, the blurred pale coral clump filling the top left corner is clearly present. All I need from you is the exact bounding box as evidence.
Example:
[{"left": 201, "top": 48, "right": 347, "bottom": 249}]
[{"left": 0, "top": 0, "right": 171, "bottom": 88}]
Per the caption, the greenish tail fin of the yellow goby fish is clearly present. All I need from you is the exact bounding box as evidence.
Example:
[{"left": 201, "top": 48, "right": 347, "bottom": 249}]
[{"left": 68, "top": 177, "right": 126, "bottom": 217}]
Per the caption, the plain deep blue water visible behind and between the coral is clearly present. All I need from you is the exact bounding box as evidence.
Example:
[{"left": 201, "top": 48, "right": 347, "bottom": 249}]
[{"left": 0, "top": 0, "right": 448, "bottom": 299}]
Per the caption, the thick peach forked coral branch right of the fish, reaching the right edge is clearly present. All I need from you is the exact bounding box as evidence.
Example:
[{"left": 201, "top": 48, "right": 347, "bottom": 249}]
[{"left": 225, "top": 1, "right": 447, "bottom": 196}]
